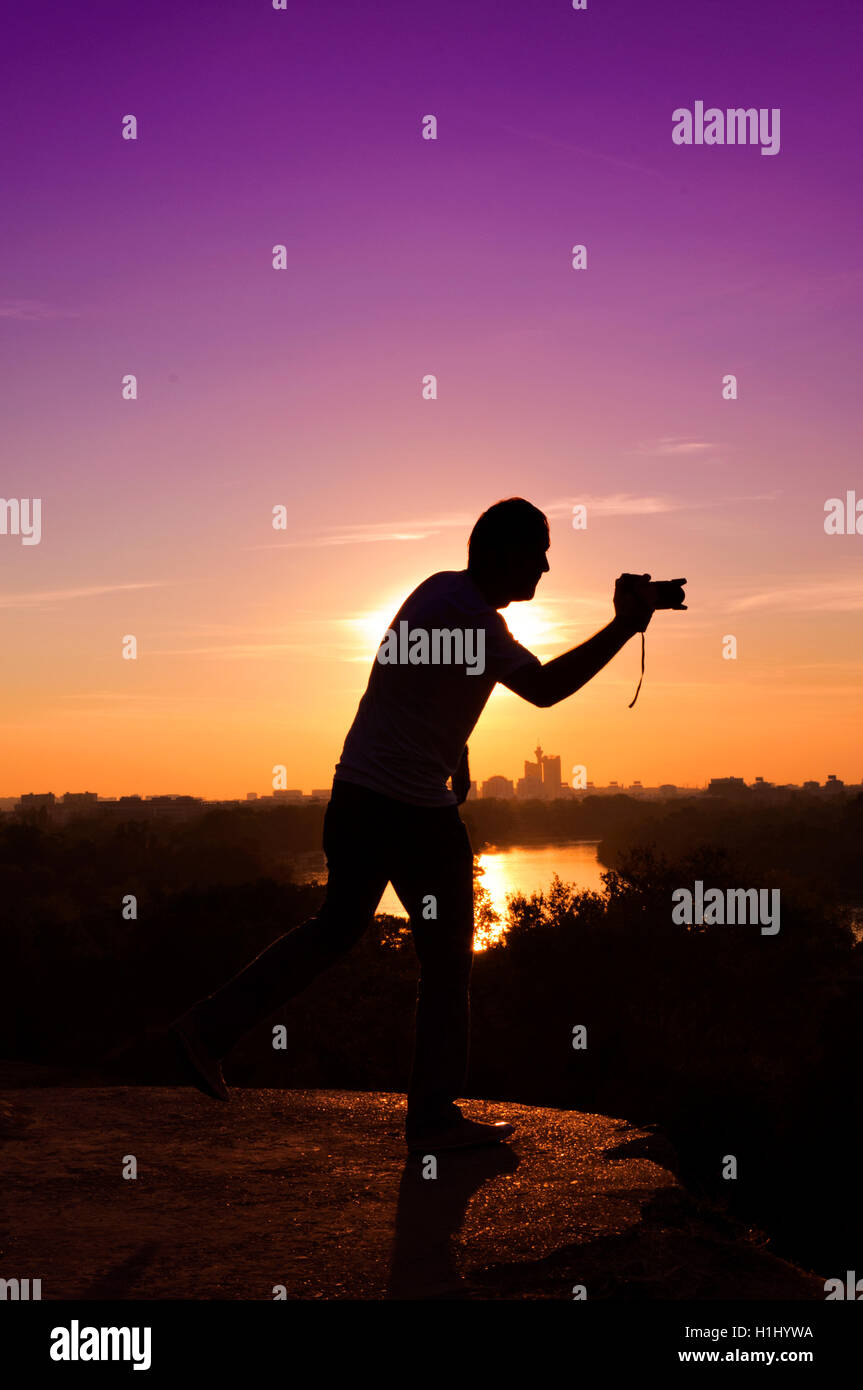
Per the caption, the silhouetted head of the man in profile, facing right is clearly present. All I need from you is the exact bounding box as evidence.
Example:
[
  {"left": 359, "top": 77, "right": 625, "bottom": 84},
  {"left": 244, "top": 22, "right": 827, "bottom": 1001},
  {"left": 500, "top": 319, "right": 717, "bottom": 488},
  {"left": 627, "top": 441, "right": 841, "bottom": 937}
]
[{"left": 467, "top": 498, "right": 549, "bottom": 607}]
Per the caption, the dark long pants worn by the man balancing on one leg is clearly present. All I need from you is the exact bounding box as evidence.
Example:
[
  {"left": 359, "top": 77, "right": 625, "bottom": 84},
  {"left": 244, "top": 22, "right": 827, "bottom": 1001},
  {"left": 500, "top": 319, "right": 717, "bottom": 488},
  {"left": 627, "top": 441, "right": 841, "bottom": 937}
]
[{"left": 196, "top": 781, "right": 474, "bottom": 1130}]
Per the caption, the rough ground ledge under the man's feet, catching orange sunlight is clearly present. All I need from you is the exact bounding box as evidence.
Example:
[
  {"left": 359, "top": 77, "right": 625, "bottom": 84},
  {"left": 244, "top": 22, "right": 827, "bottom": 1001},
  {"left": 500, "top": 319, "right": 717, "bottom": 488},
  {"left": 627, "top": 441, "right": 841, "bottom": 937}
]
[{"left": 0, "top": 1081, "right": 824, "bottom": 1300}]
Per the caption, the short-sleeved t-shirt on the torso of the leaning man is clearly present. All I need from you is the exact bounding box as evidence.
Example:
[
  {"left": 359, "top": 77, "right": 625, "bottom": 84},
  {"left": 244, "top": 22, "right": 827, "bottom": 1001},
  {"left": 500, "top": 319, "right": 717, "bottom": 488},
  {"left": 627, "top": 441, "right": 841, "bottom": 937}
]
[{"left": 335, "top": 570, "right": 536, "bottom": 806}]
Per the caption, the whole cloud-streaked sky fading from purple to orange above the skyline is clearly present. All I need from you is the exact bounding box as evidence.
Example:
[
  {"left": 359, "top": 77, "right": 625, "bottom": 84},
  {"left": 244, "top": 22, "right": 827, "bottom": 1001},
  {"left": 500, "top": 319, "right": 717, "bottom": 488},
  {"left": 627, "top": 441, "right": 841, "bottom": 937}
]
[{"left": 0, "top": 0, "right": 863, "bottom": 795}]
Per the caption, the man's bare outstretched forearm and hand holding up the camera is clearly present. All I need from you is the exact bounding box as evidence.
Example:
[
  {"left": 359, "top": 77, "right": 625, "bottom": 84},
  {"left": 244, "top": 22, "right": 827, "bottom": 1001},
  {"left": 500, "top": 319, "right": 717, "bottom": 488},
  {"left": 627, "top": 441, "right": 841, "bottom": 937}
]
[{"left": 503, "top": 574, "right": 653, "bottom": 709}]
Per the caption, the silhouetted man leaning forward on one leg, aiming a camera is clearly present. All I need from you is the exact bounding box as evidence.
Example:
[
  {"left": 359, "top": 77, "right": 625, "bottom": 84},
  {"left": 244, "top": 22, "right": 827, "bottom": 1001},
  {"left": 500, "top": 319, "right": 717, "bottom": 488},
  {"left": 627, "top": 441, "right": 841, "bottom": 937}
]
[{"left": 174, "top": 498, "right": 653, "bottom": 1151}]
